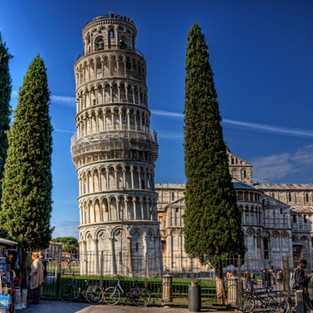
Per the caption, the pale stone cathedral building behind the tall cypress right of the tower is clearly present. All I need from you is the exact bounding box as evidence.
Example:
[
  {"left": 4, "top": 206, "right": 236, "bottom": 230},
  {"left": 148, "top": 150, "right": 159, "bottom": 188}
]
[{"left": 156, "top": 149, "right": 313, "bottom": 272}]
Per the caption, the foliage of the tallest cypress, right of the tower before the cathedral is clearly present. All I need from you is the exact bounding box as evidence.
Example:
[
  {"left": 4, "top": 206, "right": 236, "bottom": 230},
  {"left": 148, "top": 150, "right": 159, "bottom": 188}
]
[{"left": 184, "top": 24, "right": 245, "bottom": 266}]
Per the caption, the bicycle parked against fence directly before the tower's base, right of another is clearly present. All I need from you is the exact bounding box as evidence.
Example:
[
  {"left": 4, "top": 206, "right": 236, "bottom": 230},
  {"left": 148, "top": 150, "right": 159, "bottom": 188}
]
[{"left": 103, "top": 275, "right": 151, "bottom": 306}]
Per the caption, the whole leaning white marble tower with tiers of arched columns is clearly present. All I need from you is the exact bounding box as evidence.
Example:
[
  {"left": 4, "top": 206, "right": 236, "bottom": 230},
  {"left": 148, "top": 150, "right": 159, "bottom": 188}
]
[{"left": 71, "top": 14, "right": 162, "bottom": 276}]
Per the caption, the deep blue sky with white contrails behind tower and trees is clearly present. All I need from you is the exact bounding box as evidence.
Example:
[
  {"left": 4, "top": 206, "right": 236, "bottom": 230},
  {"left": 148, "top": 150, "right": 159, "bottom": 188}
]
[{"left": 0, "top": 0, "right": 313, "bottom": 236}]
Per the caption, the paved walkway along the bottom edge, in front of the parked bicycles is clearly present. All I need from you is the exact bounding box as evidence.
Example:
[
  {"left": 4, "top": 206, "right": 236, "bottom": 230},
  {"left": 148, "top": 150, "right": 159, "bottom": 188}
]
[{"left": 20, "top": 300, "right": 231, "bottom": 313}]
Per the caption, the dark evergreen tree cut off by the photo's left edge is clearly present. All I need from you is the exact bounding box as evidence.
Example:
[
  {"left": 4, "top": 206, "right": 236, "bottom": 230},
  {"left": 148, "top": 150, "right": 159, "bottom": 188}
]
[{"left": 0, "top": 33, "right": 12, "bottom": 207}]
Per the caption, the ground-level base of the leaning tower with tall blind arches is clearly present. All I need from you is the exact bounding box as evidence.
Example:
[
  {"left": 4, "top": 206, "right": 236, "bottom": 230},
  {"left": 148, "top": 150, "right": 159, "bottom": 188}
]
[{"left": 79, "top": 221, "right": 163, "bottom": 277}]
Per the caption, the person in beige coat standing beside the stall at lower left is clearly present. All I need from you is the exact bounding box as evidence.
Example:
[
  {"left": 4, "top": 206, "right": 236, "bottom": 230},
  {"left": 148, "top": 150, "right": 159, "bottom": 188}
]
[{"left": 29, "top": 252, "right": 44, "bottom": 304}]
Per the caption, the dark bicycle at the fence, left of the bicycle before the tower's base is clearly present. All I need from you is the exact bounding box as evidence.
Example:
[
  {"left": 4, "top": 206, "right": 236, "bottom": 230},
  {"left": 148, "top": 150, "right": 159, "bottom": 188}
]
[{"left": 59, "top": 277, "right": 103, "bottom": 304}]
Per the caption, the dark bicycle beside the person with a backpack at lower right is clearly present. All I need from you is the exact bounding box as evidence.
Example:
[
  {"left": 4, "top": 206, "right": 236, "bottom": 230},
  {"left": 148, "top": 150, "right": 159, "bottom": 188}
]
[{"left": 238, "top": 281, "right": 289, "bottom": 313}]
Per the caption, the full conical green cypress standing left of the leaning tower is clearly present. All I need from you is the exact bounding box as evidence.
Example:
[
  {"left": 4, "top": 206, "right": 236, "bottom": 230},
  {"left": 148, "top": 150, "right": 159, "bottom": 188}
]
[{"left": 0, "top": 56, "right": 53, "bottom": 249}]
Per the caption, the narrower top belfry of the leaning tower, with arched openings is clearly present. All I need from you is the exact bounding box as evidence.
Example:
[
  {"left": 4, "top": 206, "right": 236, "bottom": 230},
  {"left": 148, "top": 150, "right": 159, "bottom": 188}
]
[{"left": 82, "top": 13, "right": 137, "bottom": 55}]
